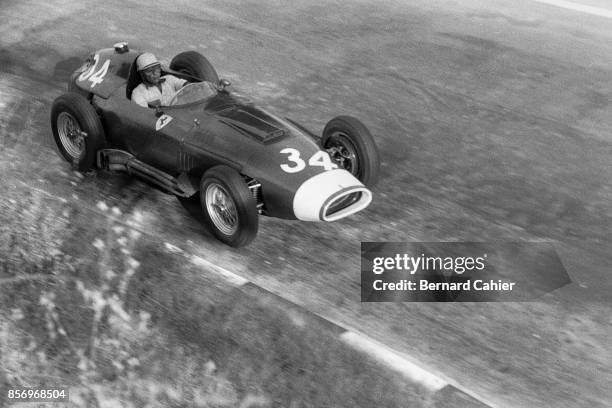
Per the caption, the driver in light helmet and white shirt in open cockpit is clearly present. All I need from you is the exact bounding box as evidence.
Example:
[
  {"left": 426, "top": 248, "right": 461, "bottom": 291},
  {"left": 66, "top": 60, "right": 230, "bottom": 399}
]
[{"left": 132, "top": 52, "right": 187, "bottom": 108}]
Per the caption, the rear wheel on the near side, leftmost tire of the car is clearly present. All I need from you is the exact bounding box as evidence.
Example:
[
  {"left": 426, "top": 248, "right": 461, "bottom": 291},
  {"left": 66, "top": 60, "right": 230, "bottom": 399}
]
[{"left": 51, "top": 92, "right": 106, "bottom": 171}]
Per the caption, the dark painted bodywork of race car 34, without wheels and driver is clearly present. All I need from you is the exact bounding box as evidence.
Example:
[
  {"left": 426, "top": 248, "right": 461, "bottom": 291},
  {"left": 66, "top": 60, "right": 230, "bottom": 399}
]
[{"left": 71, "top": 44, "right": 369, "bottom": 219}]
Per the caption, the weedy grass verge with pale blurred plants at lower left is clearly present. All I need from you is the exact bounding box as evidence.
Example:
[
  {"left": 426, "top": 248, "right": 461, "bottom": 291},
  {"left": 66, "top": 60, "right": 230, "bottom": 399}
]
[{"left": 0, "top": 183, "right": 429, "bottom": 408}]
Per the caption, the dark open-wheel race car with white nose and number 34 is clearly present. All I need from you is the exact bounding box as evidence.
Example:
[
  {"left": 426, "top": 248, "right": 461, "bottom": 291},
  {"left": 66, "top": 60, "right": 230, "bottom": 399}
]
[{"left": 51, "top": 43, "right": 380, "bottom": 247}]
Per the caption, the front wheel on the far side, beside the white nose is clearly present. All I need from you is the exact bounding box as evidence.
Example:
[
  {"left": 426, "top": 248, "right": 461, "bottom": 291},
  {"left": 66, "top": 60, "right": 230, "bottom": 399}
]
[{"left": 321, "top": 116, "right": 380, "bottom": 187}]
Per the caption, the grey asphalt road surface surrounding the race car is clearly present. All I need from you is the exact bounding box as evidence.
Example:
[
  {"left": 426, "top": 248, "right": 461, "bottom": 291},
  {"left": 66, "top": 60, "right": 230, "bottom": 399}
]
[{"left": 0, "top": 0, "right": 612, "bottom": 407}]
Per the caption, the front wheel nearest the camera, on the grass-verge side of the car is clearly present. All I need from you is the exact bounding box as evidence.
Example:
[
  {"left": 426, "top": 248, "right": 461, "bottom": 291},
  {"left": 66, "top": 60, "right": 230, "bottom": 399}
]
[{"left": 200, "top": 165, "right": 259, "bottom": 248}]
